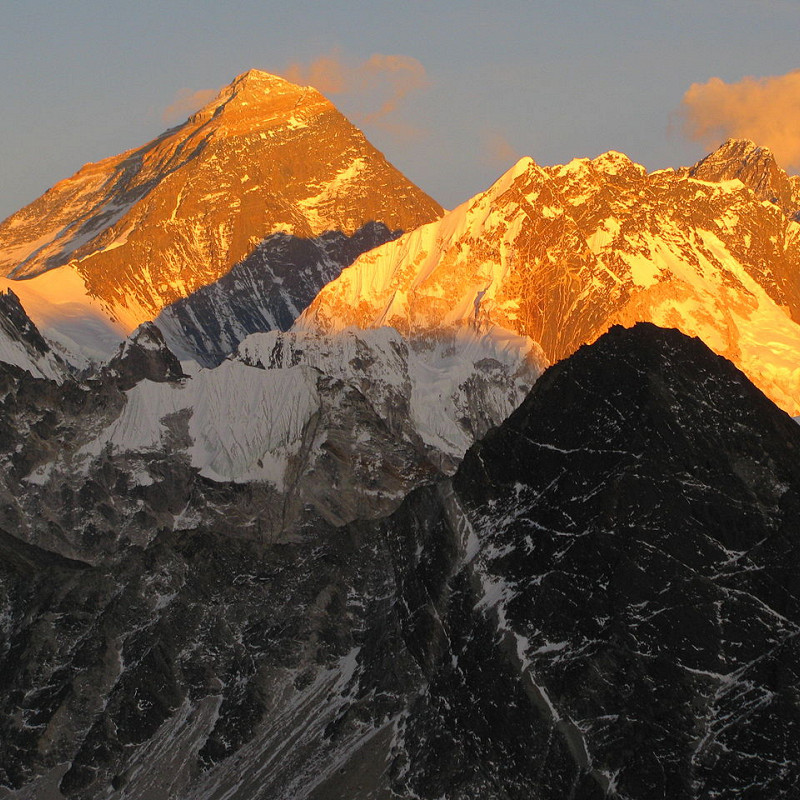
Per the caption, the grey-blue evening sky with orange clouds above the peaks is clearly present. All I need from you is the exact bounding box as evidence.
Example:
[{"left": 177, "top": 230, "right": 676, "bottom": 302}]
[{"left": 0, "top": 0, "right": 800, "bottom": 219}]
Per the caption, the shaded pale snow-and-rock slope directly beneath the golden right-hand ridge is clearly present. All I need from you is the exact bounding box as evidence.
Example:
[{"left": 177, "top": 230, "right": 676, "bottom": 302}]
[{"left": 234, "top": 327, "right": 546, "bottom": 459}]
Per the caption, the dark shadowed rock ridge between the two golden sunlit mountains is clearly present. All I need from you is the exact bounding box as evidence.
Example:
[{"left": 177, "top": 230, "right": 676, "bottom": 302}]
[{"left": 156, "top": 222, "right": 402, "bottom": 367}]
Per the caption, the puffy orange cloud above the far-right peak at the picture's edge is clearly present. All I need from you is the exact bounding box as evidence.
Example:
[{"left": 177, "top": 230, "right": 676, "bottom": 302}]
[{"left": 680, "top": 70, "right": 800, "bottom": 169}]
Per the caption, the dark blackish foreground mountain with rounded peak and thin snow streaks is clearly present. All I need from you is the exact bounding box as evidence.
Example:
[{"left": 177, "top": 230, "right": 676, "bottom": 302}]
[{"left": 0, "top": 325, "right": 800, "bottom": 800}]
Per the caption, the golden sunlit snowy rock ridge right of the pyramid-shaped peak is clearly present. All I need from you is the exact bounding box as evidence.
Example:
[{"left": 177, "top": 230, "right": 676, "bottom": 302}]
[{"left": 298, "top": 143, "right": 800, "bottom": 414}]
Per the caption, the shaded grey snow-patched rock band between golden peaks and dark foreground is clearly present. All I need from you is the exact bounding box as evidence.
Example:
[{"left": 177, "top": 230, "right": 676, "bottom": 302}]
[{"left": 0, "top": 309, "right": 542, "bottom": 562}]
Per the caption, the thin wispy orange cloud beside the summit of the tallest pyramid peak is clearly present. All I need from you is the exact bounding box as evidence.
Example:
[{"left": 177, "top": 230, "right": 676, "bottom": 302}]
[{"left": 283, "top": 50, "right": 430, "bottom": 138}]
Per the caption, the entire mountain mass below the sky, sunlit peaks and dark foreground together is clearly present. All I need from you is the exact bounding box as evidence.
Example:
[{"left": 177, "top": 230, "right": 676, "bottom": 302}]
[{"left": 0, "top": 71, "right": 800, "bottom": 800}]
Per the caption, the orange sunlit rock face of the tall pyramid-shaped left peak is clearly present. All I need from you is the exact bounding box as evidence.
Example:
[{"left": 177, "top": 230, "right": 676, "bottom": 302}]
[{"left": 0, "top": 70, "right": 441, "bottom": 330}]
